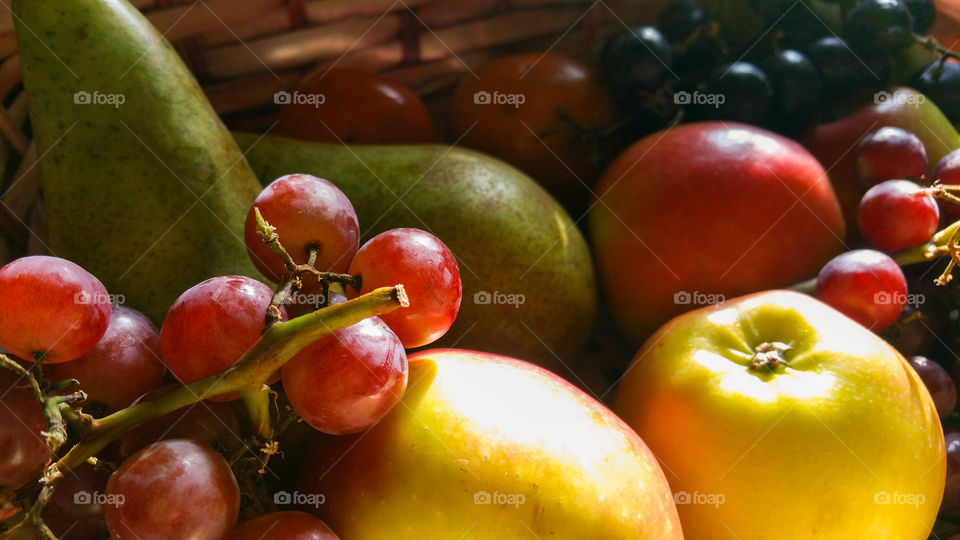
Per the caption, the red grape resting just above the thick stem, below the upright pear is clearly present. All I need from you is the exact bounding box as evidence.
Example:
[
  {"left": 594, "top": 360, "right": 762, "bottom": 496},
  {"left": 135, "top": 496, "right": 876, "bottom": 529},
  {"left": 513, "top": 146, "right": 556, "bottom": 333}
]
[{"left": 160, "top": 276, "right": 273, "bottom": 401}]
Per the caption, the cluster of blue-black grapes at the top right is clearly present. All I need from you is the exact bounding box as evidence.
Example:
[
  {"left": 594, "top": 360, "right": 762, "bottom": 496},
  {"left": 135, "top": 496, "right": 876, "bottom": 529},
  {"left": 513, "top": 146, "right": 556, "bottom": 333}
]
[{"left": 600, "top": 0, "right": 936, "bottom": 134}]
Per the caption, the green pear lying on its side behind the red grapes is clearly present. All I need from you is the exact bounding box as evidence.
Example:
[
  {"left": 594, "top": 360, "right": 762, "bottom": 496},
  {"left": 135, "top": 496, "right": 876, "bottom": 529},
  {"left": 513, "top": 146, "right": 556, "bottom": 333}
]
[{"left": 236, "top": 134, "right": 597, "bottom": 375}]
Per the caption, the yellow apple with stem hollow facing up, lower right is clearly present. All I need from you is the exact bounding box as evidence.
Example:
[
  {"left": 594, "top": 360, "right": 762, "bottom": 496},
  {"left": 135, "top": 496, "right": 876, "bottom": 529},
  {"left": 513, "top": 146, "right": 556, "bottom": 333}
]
[{"left": 613, "top": 291, "right": 946, "bottom": 540}]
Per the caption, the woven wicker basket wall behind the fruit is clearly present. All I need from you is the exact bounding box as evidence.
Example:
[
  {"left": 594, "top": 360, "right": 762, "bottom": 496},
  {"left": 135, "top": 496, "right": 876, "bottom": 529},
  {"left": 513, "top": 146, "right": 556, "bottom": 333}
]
[{"left": 0, "top": 0, "right": 960, "bottom": 265}]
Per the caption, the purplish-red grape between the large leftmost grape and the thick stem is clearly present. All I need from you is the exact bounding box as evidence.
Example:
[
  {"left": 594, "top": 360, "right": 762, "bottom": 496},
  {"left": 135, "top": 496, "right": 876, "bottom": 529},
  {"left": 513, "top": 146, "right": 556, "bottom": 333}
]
[{"left": 43, "top": 306, "right": 166, "bottom": 416}]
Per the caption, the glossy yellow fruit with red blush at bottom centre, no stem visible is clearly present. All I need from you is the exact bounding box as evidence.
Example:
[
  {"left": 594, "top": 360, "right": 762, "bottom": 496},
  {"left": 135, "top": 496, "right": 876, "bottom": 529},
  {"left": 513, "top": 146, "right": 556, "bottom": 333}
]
[{"left": 297, "top": 349, "right": 683, "bottom": 540}]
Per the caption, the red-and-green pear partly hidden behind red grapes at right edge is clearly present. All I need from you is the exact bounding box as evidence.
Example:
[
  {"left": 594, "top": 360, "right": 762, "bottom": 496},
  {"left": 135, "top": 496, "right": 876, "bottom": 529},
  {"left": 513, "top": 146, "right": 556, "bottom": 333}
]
[{"left": 803, "top": 88, "right": 960, "bottom": 235}]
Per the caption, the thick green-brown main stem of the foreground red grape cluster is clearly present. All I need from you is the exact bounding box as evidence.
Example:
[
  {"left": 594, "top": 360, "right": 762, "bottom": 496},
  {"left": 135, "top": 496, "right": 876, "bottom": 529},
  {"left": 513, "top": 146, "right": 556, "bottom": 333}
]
[{"left": 54, "top": 285, "right": 409, "bottom": 471}]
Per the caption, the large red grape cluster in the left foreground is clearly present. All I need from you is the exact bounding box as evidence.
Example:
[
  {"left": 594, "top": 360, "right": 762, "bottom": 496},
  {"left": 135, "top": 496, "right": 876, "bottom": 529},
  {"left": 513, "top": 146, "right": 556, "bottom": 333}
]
[{"left": 0, "top": 174, "right": 462, "bottom": 539}]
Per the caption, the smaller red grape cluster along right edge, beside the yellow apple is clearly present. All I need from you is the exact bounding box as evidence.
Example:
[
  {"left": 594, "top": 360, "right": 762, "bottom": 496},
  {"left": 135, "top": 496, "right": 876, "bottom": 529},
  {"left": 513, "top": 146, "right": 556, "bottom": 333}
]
[{"left": 814, "top": 126, "right": 960, "bottom": 518}]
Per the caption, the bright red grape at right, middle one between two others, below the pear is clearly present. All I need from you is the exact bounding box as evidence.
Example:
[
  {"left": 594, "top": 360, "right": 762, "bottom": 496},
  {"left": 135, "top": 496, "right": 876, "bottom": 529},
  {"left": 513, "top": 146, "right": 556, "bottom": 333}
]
[{"left": 857, "top": 180, "right": 940, "bottom": 252}]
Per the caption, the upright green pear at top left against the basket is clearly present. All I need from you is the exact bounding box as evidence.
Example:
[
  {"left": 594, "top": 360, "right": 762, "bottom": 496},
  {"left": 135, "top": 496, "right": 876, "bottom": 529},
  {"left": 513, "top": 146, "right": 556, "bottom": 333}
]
[{"left": 12, "top": 0, "right": 260, "bottom": 323}]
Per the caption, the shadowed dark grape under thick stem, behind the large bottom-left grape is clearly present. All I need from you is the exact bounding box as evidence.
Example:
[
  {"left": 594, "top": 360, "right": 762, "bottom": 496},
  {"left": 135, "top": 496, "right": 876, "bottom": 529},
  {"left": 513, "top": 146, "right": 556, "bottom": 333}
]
[{"left": 111, "top": 384, "right": 244, "bottom": 460}]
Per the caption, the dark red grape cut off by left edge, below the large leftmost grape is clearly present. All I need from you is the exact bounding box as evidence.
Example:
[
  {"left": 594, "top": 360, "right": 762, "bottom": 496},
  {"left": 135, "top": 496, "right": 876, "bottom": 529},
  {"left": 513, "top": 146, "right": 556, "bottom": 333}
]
[{"left": 0, "top": 369, "right": 53, "bottom": 490}]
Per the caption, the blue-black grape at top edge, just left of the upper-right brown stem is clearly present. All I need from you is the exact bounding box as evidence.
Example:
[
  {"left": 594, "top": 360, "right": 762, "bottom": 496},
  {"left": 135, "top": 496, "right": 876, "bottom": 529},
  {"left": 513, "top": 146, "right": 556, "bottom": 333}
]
[{"left": 843, "top": 0, "right": 913, "bottom": 54}]
